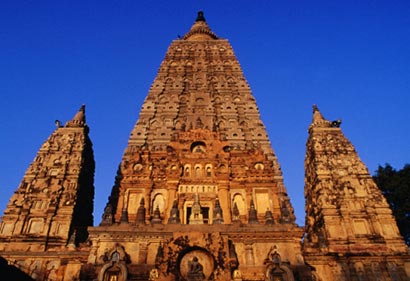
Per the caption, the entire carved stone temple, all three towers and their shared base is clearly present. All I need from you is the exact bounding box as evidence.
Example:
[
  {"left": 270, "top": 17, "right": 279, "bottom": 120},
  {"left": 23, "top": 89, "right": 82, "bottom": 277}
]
[{"left": 0, "top": 12, "right": 410, "bottom": 281}]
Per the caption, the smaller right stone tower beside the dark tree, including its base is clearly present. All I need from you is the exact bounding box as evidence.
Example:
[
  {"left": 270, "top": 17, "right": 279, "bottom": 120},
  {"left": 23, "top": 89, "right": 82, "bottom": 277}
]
[{"left": 303, "top": 106, "right": 409, "bottom": 280}]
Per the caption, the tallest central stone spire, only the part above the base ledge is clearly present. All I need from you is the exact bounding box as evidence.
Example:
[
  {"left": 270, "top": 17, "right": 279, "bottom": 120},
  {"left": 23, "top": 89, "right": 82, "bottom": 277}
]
[{"left": 109, "top": 12, "right": 295, "bottom": 224}]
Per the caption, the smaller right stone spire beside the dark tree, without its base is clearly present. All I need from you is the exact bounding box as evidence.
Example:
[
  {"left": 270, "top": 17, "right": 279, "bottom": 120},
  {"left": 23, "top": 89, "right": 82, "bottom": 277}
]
[{"left": 304, "top": 106, "right": 406, "bottom": 278}]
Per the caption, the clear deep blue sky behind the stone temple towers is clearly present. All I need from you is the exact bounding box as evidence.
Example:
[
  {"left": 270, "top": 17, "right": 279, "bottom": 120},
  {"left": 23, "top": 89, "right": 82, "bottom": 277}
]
[{"left": 0, "top": 0, "right": 410, "bottom": 225}]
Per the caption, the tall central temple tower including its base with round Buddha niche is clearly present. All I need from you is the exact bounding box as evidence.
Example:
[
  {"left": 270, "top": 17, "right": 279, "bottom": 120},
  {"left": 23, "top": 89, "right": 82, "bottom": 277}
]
[{"left": 89, "top": 12, "right": 308, "bottom": 280}]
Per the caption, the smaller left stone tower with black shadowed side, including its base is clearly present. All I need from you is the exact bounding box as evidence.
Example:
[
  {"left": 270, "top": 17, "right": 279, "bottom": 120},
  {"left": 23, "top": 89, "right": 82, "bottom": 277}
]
[{"left": 0, "top": 106, "right": 94, "bottom": 280}]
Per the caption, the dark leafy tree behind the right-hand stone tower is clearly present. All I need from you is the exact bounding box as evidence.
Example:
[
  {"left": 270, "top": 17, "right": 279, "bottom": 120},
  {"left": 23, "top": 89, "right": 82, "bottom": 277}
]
[{"left": 373, "top": 164, "right": 410, "bottom": 246}]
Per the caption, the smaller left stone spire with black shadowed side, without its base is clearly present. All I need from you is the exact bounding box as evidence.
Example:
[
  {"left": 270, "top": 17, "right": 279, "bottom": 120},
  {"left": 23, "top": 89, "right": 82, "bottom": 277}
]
[{"left": 0, "top": 106, "right": 94, "bottom": 250}]
